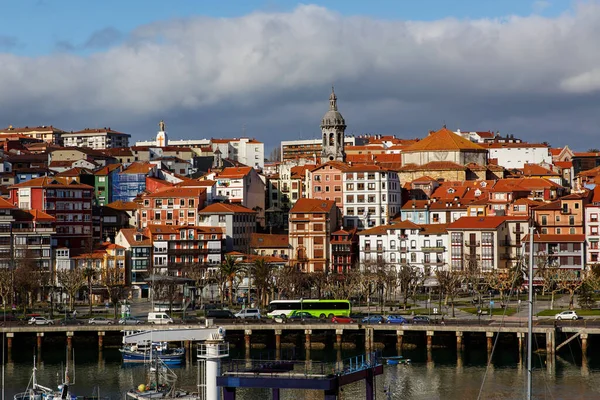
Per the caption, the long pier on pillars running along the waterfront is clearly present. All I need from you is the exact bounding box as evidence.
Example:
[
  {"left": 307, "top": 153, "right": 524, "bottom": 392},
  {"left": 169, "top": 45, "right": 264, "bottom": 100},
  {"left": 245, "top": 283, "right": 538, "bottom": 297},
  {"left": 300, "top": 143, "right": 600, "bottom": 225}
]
[{"left": 0, "top": 319, "right": 600, "bottom": 354}]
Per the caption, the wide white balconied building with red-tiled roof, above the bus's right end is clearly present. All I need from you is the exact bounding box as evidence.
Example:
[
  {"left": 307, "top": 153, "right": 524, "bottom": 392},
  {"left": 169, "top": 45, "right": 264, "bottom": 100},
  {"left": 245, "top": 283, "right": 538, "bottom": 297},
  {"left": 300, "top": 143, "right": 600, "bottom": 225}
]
[{"left": 358, "top": 221, "right": 448, "bottom": 276}]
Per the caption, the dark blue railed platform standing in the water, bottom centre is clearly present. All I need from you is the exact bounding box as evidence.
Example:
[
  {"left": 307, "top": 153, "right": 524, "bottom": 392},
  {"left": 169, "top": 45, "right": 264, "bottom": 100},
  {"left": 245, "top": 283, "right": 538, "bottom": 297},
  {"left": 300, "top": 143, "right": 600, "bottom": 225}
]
[{"left": 217, "top": 353, "right": 383, "bottom": 400}]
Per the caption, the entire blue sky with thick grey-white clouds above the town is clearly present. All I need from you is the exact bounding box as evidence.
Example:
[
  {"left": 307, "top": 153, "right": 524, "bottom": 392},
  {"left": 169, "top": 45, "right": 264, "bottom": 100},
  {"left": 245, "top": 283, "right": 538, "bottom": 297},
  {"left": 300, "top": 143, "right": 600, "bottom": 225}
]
[{"left": 0, "top": 0, "right": 600, "bottom": 153}]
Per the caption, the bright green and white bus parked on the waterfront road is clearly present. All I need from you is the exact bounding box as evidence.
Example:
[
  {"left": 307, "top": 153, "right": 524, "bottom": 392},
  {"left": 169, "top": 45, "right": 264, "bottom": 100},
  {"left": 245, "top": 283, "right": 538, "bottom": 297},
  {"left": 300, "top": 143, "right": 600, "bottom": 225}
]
[{"left": 267, "top": 299, "right": 352, "bottom": 318}]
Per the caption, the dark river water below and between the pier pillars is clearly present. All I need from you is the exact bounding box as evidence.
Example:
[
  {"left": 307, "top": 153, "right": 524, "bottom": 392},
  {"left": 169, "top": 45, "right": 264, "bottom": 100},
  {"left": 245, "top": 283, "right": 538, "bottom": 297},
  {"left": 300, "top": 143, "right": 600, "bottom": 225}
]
[{"left": 4, "top": 343, "right": 600, "bottom": 400}]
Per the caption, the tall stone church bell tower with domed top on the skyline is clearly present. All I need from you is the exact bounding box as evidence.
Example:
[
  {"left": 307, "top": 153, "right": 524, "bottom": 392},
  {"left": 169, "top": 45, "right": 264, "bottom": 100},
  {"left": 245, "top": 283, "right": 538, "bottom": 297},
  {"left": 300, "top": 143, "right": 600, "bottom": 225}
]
[{"left": 321, "top": 86, "right": 346, "bottom": 163}]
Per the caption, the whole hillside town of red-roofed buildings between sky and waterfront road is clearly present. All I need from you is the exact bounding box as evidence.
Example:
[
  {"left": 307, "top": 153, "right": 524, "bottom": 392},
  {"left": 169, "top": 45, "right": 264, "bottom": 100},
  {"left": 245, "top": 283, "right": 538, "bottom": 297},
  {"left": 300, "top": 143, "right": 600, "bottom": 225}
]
[{"left": 0, "top": 89, "right": 600, "bottom": 312}]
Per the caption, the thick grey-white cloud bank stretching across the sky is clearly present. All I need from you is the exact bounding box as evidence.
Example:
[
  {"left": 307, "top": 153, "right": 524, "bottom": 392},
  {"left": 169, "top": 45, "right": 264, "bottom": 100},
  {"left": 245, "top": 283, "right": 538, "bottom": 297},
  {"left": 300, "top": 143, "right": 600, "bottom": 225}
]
[{"left": 0, "top": 2, "right": 600, "bottom": 149}]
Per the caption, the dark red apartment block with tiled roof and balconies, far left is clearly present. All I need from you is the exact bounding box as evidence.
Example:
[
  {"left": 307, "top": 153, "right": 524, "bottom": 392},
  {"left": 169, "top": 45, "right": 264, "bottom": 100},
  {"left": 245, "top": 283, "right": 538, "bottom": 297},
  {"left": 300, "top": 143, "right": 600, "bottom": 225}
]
[{"left": 9, "top": 177, "right": 94, "bottom": 250}]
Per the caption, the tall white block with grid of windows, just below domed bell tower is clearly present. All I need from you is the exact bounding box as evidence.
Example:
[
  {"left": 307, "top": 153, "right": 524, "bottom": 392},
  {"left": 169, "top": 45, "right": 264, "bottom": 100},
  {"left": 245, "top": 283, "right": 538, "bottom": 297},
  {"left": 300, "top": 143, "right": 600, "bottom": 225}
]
[{"left": 342, "top": 165, "right": 402, "bottom": 229}]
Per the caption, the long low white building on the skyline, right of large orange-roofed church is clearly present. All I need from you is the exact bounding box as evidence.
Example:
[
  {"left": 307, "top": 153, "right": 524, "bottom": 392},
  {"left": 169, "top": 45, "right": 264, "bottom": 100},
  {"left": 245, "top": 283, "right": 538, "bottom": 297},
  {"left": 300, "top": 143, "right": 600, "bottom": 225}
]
[{"left": 482, "top": 143, "right": 552, "bottom": 169}]
